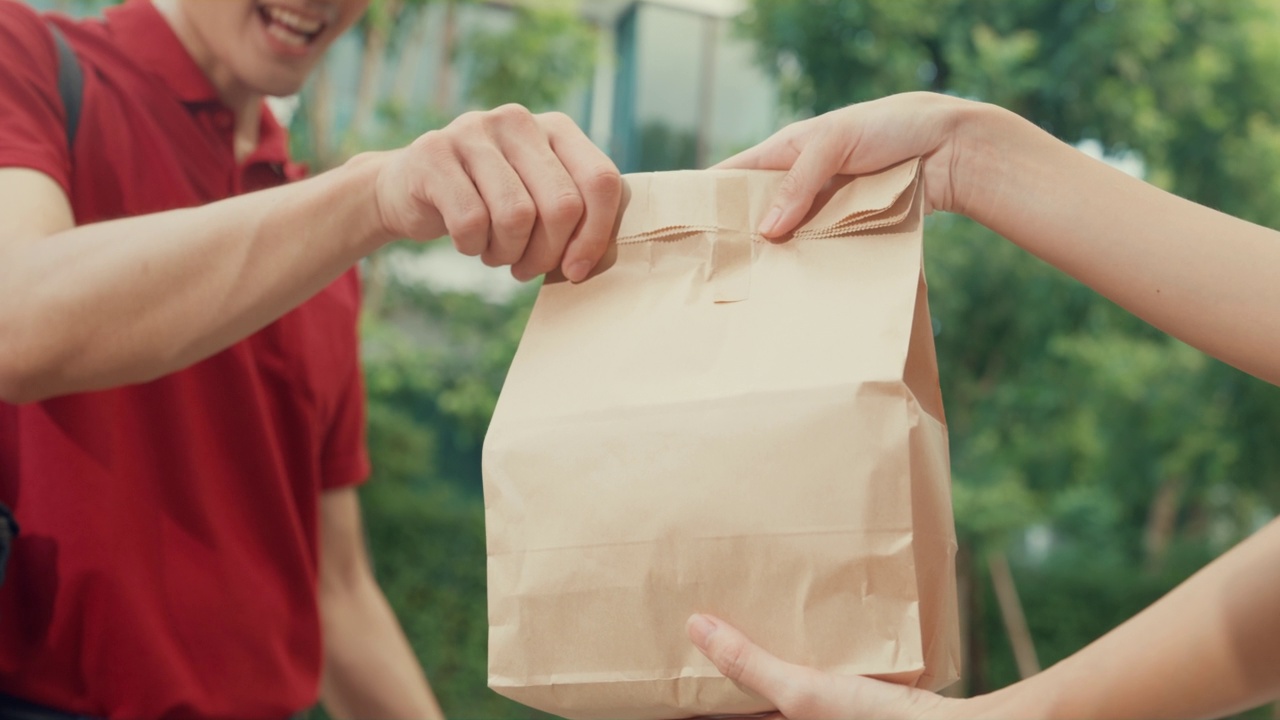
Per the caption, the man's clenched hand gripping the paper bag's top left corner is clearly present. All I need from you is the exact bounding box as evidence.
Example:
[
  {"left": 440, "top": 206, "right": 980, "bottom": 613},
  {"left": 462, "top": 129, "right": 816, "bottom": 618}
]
[{"left": 376, "top": 105, "right": 622, "bottom": 282}]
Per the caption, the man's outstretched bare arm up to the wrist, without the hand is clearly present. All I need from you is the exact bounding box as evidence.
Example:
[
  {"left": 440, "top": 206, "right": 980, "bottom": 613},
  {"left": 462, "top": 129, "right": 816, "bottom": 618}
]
[{"left": 0, "top": 163, "right": 390, "bottom": 402}]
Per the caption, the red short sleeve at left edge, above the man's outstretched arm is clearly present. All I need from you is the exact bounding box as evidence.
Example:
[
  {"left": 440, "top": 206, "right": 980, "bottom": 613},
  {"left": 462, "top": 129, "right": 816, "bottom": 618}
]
[{"left": 0, "top": 0, "right": 72, "bottom": 195}]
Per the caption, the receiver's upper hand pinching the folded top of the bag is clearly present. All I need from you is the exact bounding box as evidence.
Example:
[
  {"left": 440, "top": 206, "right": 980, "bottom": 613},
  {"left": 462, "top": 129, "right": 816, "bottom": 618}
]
[{"left": 717, "top": 92, "right": 986, "bottom": 237}]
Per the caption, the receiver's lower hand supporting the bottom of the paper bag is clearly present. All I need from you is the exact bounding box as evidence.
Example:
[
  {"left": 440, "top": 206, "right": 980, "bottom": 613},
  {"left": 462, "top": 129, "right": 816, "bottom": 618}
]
[{"left": 686, "top": 615, "right": 972, "bottom": 720}]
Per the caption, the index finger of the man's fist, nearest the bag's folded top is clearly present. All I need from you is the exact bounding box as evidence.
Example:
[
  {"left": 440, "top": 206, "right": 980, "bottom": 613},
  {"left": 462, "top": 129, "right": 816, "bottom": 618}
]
[{"left": 540, "top": 113, "right": 622, "bottom": 282}]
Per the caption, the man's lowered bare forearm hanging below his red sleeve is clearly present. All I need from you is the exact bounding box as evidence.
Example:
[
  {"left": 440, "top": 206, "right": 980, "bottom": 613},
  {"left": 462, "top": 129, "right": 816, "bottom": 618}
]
[{"left": 320, "top": 488, "right": 444, "bottom": 720}]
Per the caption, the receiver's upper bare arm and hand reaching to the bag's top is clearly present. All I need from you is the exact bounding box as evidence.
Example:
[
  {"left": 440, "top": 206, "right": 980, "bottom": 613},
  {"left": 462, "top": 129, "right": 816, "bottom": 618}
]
[{"left": 722, "top": 94, "right": 1280, "bottom": 383}]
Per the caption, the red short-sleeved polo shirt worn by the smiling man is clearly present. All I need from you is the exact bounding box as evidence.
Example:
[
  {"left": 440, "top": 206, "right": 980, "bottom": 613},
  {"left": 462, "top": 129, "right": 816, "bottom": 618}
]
[{"left": 0, "top": 0, "right": 369, "bottom": 717}]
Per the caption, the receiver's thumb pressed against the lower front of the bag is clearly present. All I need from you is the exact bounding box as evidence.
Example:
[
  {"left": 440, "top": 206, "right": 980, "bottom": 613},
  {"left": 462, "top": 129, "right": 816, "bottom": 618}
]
[{"left": 685, "top": 615, "right": 799, "bottom": 707}]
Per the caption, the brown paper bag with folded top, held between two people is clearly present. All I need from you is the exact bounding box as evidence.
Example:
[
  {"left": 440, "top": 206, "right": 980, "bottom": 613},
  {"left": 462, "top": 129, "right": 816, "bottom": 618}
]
[{"left": 484, "top": 161, "right": 959, "bottom": 719}]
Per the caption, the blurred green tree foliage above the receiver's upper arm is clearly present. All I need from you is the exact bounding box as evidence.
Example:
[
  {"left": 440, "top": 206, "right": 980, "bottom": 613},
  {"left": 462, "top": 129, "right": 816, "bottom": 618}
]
[{"left": 741, "top": 0, "right": 1280, "bottom": 227}]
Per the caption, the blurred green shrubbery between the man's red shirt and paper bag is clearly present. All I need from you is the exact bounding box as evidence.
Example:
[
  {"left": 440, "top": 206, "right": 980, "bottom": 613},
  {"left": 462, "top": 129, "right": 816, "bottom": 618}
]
[{"left": 361, "top": 277, "right": 540, "bottom": 719}]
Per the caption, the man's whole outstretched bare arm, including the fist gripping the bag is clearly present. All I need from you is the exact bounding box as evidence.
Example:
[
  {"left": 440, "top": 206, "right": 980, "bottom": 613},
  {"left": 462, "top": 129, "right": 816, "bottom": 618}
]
[{"left": 0, "top": 106, "right": 622, "bottom": 402}]
